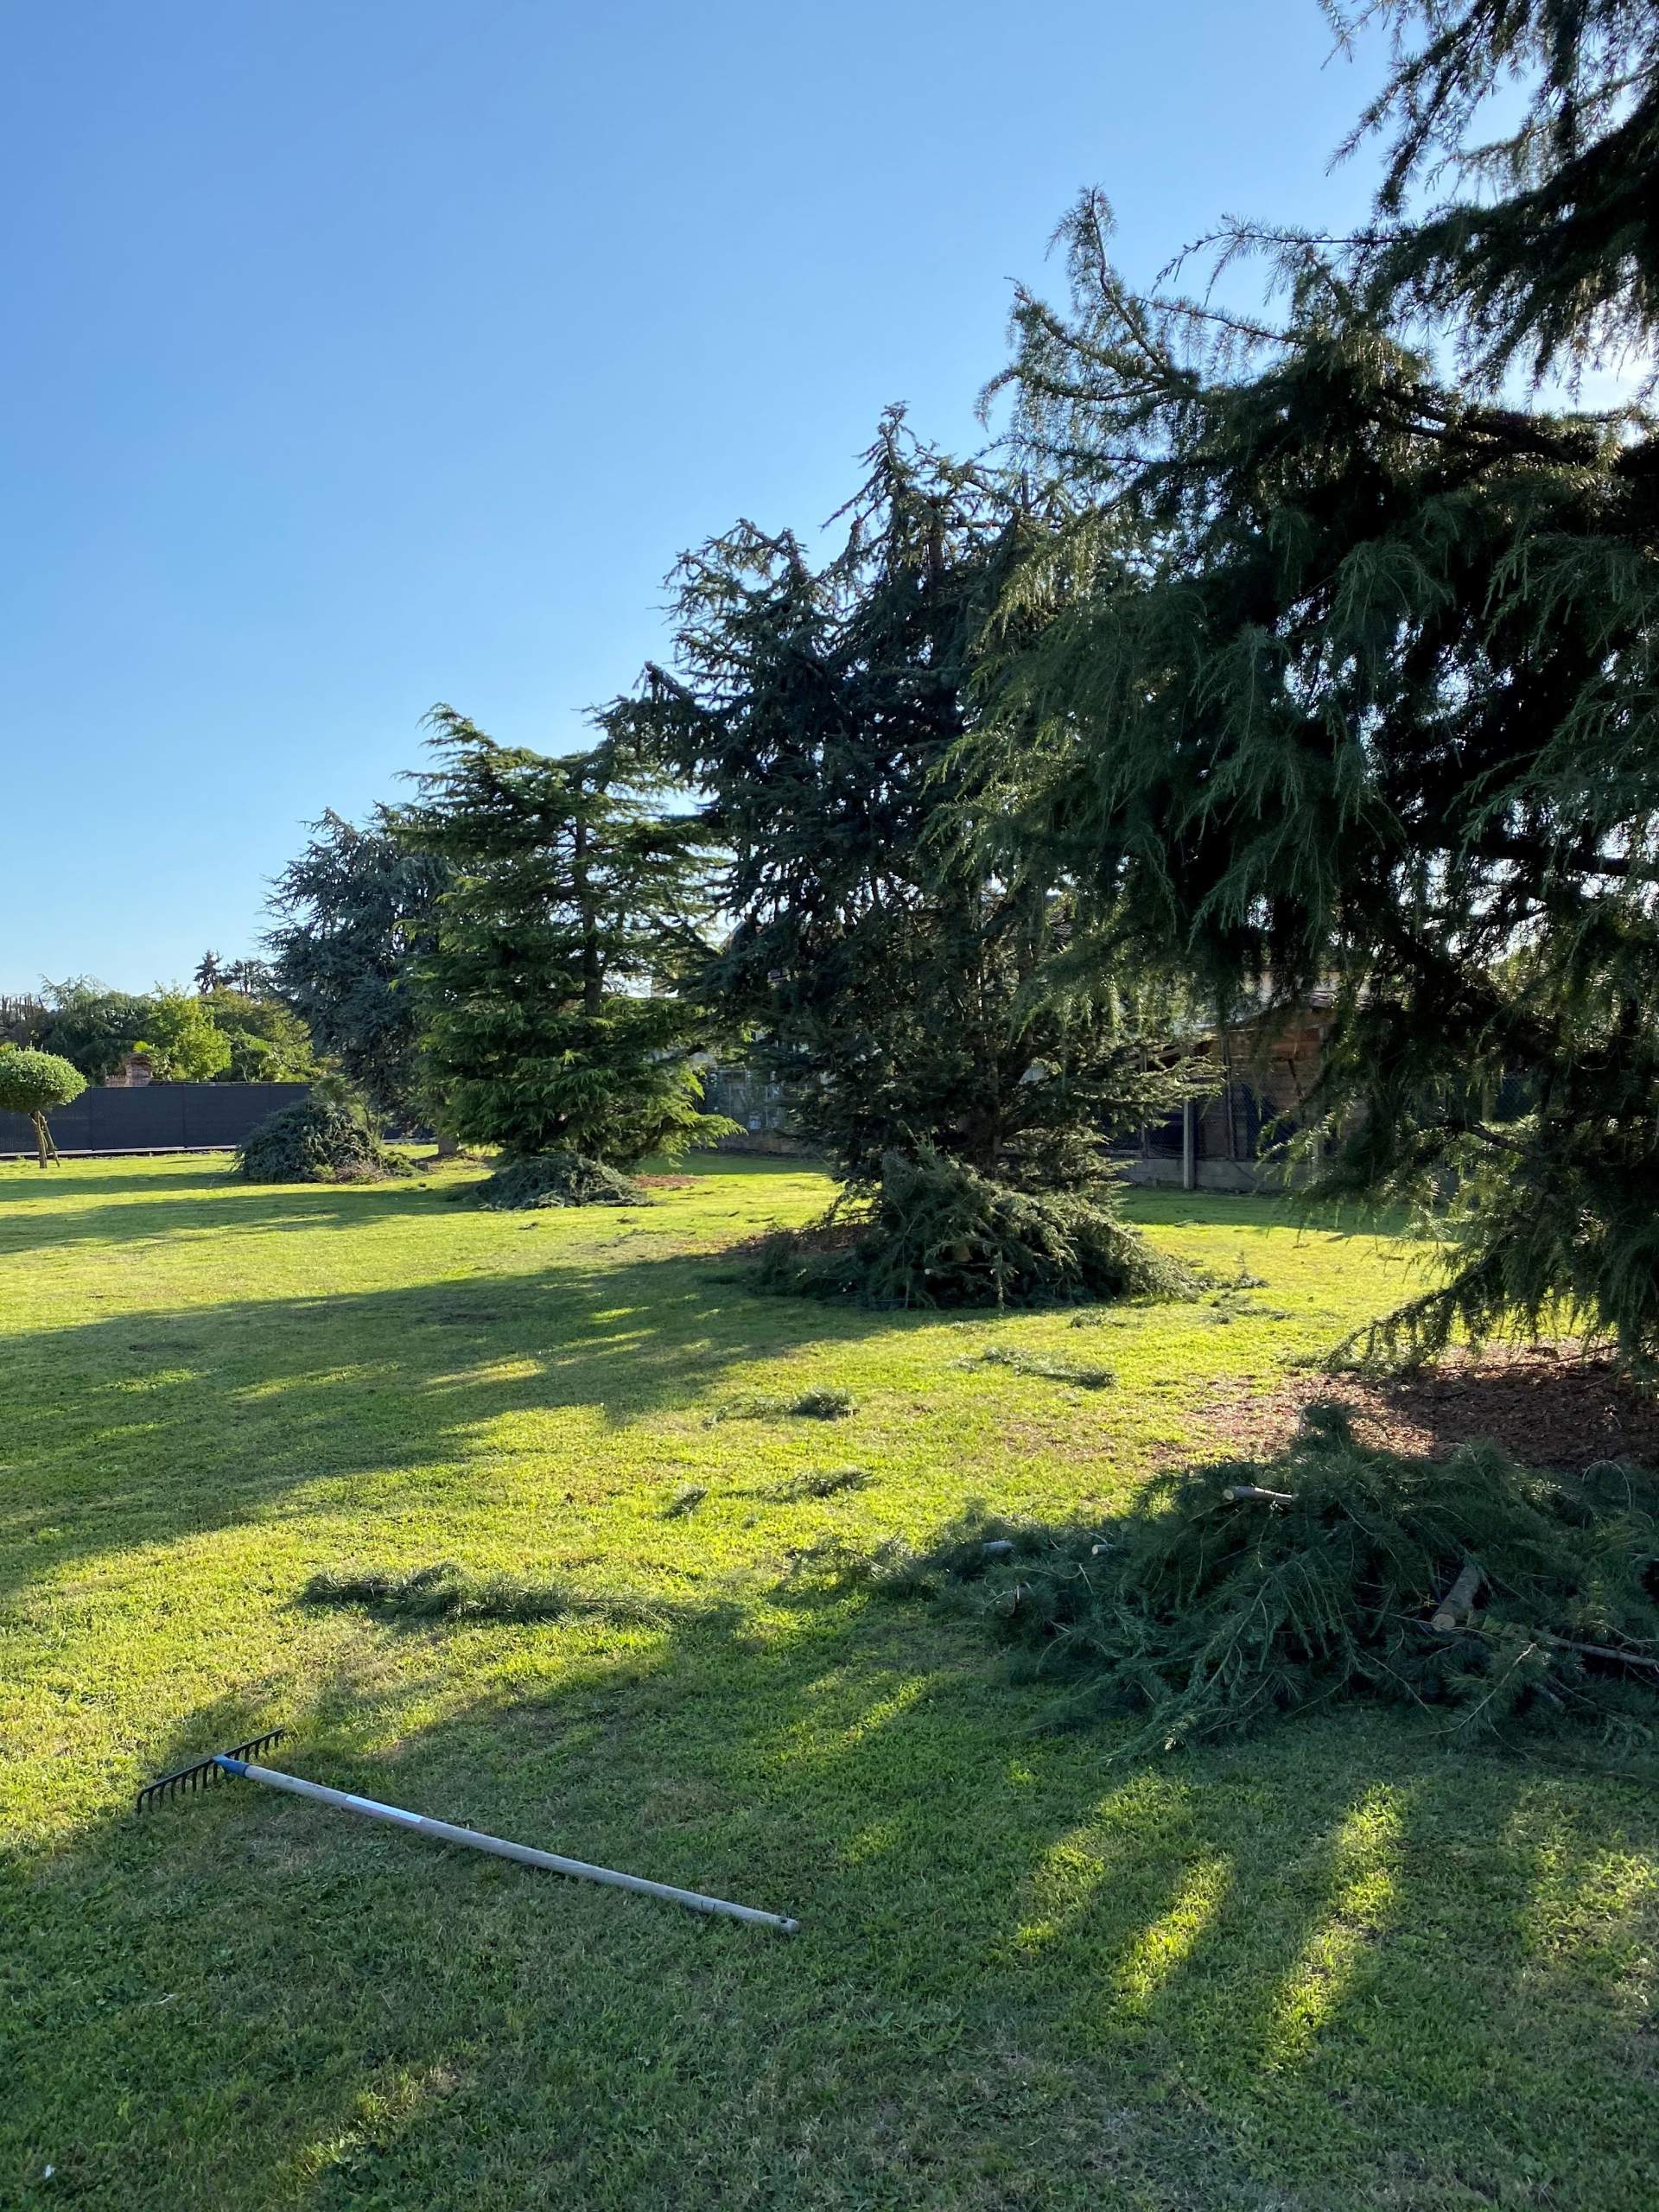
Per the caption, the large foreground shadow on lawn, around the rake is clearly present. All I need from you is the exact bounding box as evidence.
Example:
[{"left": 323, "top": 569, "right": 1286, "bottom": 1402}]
[{"left": 9, "top": 1599, "right": 1659, "bottom": 2212}]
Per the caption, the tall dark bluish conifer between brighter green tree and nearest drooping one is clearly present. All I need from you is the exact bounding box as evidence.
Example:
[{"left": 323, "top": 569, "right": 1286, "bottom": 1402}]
[{"left": 606, "top": 414, "right": 1184, "bottom": 1299}]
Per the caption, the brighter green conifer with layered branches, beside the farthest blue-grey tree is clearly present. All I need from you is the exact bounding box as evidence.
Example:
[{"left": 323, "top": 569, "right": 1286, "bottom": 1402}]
[{"left": 400, "top": 708, "right": 732, "bottom": 1204}]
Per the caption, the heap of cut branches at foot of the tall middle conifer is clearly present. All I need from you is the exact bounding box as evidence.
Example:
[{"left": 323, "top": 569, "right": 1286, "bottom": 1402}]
[{"left": 757, "top": 1146, "right": 1197, "bottom": 1307}]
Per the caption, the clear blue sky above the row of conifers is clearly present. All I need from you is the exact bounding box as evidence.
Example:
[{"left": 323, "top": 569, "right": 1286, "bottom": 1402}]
[{"left": 0, "top": 0, "right": 1376, "bottom": 988}]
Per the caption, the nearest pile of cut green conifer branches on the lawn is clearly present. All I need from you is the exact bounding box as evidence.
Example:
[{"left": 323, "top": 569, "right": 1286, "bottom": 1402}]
[{"left": 869, "top": 1405, "right": 1659, "bottom": 1758}]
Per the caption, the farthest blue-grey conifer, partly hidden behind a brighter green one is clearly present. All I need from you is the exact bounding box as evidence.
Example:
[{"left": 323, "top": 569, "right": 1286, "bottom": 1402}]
[{"left": 270, "top": 807, "right": 445, "bottom": 1123}]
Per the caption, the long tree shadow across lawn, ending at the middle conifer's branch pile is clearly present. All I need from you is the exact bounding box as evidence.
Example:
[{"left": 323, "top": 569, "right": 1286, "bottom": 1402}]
[{"left": 0, "top": 1255, "right": 909, "bottom": 1588}]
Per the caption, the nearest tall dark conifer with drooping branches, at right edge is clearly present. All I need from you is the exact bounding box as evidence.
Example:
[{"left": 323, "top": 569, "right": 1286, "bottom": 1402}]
[{"left": 980, "top": 0, "right": 1659, "bottom": 1367}]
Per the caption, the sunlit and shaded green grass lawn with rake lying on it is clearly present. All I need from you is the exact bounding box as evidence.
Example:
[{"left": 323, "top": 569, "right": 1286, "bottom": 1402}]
[{"left": 0, "top": 1159, "right": 1659, "bottom": 2212}]
